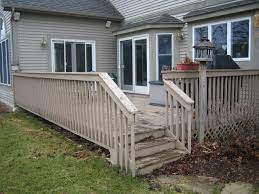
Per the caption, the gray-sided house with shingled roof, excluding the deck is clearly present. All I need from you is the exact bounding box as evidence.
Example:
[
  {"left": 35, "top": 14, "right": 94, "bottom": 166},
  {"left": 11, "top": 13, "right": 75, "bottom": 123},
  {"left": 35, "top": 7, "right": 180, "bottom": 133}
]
[{"left": 0, "top": 0, "right": 259, "bottom": 106}]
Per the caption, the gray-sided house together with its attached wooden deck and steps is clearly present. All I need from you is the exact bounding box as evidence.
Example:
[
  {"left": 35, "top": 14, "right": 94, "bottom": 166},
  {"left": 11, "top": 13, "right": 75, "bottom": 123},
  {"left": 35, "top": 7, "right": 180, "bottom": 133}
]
[{"left": 0, "top": 0, "right": 259, "bottom": 176}]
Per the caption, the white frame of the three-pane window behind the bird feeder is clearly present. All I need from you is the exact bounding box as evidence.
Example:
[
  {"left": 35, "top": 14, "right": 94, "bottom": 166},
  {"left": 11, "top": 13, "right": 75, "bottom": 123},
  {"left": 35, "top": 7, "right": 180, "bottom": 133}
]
[{"left": 192, "top": 16, "right": 252, "bottom": 61}]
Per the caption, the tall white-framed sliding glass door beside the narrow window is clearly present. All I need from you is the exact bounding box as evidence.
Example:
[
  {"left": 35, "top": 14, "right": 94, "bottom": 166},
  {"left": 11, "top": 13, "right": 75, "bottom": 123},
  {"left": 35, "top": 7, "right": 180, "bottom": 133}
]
[{"left": 119, "top": 36, "right": 149, "bottom": 94}]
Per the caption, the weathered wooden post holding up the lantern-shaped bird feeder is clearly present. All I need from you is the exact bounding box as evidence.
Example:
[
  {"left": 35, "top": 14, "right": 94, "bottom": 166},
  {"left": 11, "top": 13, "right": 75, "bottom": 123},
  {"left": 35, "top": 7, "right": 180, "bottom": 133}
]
[{"left": 199, "top": 62, "right": 207, "bottom": 143}]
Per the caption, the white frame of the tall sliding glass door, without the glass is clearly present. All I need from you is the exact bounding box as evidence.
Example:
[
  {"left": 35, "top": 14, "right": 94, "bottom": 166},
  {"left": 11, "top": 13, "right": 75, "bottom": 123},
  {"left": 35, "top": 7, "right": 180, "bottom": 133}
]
[{"left": 118, "top": 34, "right": 150, "bottom": 94}]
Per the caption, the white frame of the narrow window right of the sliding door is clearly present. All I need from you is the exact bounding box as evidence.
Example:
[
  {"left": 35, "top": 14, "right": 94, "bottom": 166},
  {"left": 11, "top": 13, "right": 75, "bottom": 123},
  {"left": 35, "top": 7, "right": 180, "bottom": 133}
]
[{"left": 156, "top": 32, "right": 175, "bottom": 80}]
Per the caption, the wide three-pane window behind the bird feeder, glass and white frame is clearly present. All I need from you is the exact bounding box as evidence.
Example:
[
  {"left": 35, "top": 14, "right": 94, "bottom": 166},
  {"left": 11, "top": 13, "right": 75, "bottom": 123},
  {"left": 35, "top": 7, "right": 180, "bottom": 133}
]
[{"left": 193, "top": 18, "right": 251, "bottom": 61}]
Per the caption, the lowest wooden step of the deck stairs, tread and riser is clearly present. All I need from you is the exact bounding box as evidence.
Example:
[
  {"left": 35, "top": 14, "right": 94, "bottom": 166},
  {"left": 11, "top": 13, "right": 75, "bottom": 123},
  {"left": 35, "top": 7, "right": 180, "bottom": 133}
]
[{"left": 136, "top": 149, "right": 186, "bottom": 175}]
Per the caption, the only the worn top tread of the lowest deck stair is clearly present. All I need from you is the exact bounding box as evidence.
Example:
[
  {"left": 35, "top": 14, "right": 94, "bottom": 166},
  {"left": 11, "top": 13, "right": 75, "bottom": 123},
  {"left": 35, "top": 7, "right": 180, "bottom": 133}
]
[{"left": 136, "top": 149, "right": 186, "bottom": 169}]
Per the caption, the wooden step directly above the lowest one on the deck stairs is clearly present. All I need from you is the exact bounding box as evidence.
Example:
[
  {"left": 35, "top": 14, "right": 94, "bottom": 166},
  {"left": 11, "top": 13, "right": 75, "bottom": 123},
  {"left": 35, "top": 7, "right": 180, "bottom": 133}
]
[{"left": 135, "top": 136, "right": 175, "bottom": 158}]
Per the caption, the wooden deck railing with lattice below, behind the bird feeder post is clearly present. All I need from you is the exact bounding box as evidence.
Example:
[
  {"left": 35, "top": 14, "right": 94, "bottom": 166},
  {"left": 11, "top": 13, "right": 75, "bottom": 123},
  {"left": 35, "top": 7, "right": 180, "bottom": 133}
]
[{"left": 163, "top": 69, "right": 259, "bottom": 139}]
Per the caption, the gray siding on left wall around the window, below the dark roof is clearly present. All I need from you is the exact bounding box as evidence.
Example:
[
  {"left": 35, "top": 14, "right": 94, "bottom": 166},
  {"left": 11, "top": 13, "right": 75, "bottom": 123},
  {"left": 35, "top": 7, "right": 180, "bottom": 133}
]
[{"left": 16, "top": 13, "right": 120, "bottom": 72}]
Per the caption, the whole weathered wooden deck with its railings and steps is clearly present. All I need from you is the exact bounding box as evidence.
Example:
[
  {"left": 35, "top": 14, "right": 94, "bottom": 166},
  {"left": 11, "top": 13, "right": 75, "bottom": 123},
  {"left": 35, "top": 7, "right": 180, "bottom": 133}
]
[{"left": 13, "top": 70, "right": 259, "bottom": 176}]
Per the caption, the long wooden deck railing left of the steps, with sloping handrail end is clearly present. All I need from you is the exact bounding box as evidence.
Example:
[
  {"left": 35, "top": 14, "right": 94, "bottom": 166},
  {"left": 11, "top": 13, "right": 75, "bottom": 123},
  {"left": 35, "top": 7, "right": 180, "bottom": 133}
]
[{"left": 14, "top": 73, "right": 140, "bottom": 176}]
